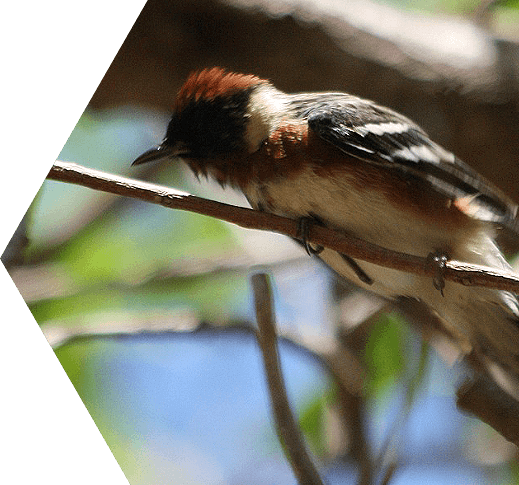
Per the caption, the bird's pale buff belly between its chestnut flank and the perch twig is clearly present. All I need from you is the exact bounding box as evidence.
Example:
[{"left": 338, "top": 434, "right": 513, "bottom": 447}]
[{"left": 245, "top": 164, "right": 473, "bottom": 256}]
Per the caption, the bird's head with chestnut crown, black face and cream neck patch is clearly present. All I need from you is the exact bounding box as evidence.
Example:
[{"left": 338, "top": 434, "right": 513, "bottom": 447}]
[{"left": 133, "top": 67, "right": 283, "bottom": 165}]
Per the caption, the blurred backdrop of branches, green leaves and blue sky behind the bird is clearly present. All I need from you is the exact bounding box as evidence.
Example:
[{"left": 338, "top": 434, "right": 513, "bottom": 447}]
[{"left": 2, "top": 0, "right": 519, "bottom": 485}]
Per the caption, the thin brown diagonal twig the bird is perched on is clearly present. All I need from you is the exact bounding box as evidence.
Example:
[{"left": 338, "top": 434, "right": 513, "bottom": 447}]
[{"left": 47, "top": 161, "right": 519, "bottom": 294}]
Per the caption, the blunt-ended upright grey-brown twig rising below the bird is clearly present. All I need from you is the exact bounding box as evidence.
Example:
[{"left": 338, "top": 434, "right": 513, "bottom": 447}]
[{"left": 252, "top": 273, "right": 323, "bottom": 485}]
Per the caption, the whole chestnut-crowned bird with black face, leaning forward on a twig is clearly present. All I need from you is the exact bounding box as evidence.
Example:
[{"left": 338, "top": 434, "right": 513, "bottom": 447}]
[{"left": 133, "top": 67, "right": 519, "bottom": 399}]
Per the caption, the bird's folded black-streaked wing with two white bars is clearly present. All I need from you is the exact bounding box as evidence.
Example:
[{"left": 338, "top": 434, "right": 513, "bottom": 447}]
[{"left": 291, "top": 93, "right": 519, "bottom": 234}]
